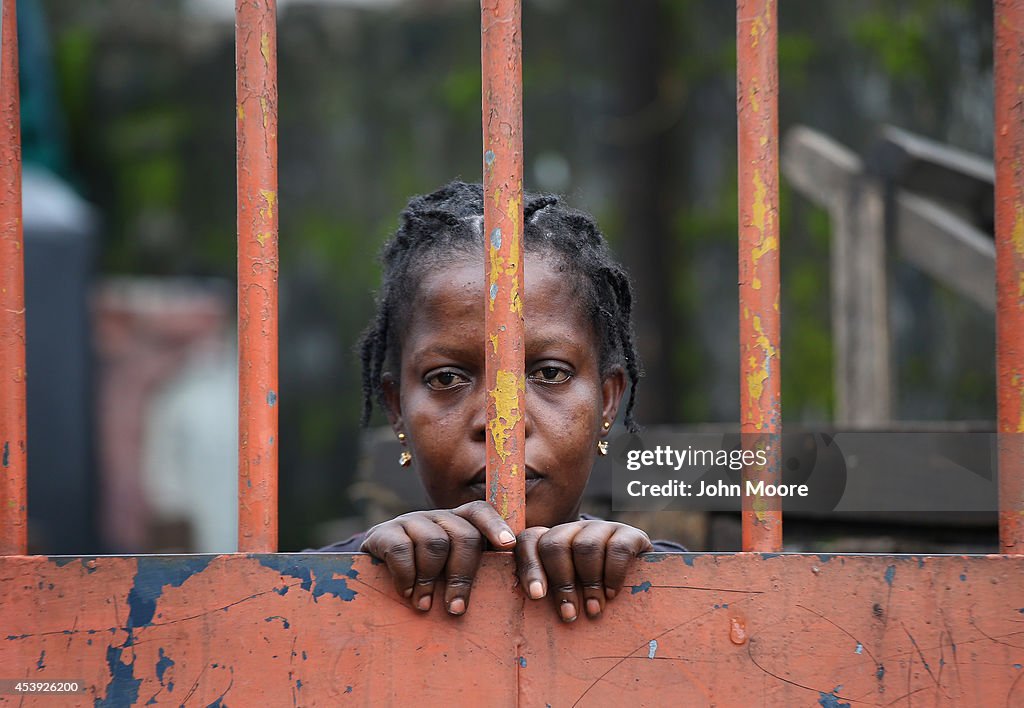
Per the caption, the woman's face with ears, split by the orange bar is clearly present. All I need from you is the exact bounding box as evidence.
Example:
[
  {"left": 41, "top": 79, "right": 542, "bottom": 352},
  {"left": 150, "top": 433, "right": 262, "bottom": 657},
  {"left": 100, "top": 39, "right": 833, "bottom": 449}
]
[{"left": 384, "top": 253, "right": 626, "bottom": 527}]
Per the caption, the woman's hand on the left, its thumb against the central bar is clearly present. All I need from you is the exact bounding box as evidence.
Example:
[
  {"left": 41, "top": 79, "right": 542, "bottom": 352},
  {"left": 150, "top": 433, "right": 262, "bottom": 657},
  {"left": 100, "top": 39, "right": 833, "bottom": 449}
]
[{"left": 359, "top": 501, "right": 520, "bottom": 615}]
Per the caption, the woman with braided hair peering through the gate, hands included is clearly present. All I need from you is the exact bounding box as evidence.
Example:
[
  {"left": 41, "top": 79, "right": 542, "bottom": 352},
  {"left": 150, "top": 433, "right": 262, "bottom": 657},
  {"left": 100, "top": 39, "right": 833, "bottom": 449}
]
[{"left": 323, "top": 182, "right": 684, "bottom": 622}]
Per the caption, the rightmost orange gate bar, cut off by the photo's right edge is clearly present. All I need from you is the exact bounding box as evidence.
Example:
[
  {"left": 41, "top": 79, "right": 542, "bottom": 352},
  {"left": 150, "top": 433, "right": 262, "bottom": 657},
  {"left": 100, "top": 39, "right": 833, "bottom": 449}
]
[{"left": 993, "top": 0, "right": 1024, "bottom": 553}]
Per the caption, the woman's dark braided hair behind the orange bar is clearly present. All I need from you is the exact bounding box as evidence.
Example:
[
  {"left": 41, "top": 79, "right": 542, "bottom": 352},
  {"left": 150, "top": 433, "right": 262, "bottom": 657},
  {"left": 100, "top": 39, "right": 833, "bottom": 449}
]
[{"left": 358, "top": 181, "right": 641, "bottom": 431}]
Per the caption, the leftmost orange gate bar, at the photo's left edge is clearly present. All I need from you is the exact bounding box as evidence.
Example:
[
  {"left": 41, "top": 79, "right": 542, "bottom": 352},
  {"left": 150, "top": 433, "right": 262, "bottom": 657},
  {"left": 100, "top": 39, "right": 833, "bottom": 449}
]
[{"left": 0, "top": 0, "right": 29, "bottom": 555}]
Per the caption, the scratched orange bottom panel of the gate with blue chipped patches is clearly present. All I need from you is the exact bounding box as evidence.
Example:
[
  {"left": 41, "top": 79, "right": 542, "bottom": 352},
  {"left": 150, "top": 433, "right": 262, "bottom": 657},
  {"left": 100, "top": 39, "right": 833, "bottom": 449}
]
[{"left": 0, "top": 553, "right": 1024, "bottom": 706}]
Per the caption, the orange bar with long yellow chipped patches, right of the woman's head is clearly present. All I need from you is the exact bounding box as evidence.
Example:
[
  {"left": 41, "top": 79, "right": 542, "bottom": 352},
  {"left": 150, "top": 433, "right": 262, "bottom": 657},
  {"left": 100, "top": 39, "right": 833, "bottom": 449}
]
[{"left": 736, "top": 0, "right": 782, "bottom": 551}]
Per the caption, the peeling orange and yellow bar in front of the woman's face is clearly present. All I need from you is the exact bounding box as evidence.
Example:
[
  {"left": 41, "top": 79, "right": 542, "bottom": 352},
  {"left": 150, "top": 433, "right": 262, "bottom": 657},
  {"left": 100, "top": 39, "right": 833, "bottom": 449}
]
[{"left": 480, "top": 0, "right": 526, "bottom": 534}]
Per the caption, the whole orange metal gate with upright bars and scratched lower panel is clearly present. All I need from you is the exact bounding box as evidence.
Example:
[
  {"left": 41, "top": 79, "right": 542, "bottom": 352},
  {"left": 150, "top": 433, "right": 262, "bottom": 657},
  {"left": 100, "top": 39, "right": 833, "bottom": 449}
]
[{"left": 0, "top": 0, "right": 1024, "bottom": 708}]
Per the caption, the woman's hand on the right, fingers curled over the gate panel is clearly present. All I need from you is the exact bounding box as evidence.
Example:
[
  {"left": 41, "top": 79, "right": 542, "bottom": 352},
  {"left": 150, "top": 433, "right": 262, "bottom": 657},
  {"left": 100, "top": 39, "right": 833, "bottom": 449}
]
[{"left": 515, "top": 519, "right": 652, "bottom": 622}]
